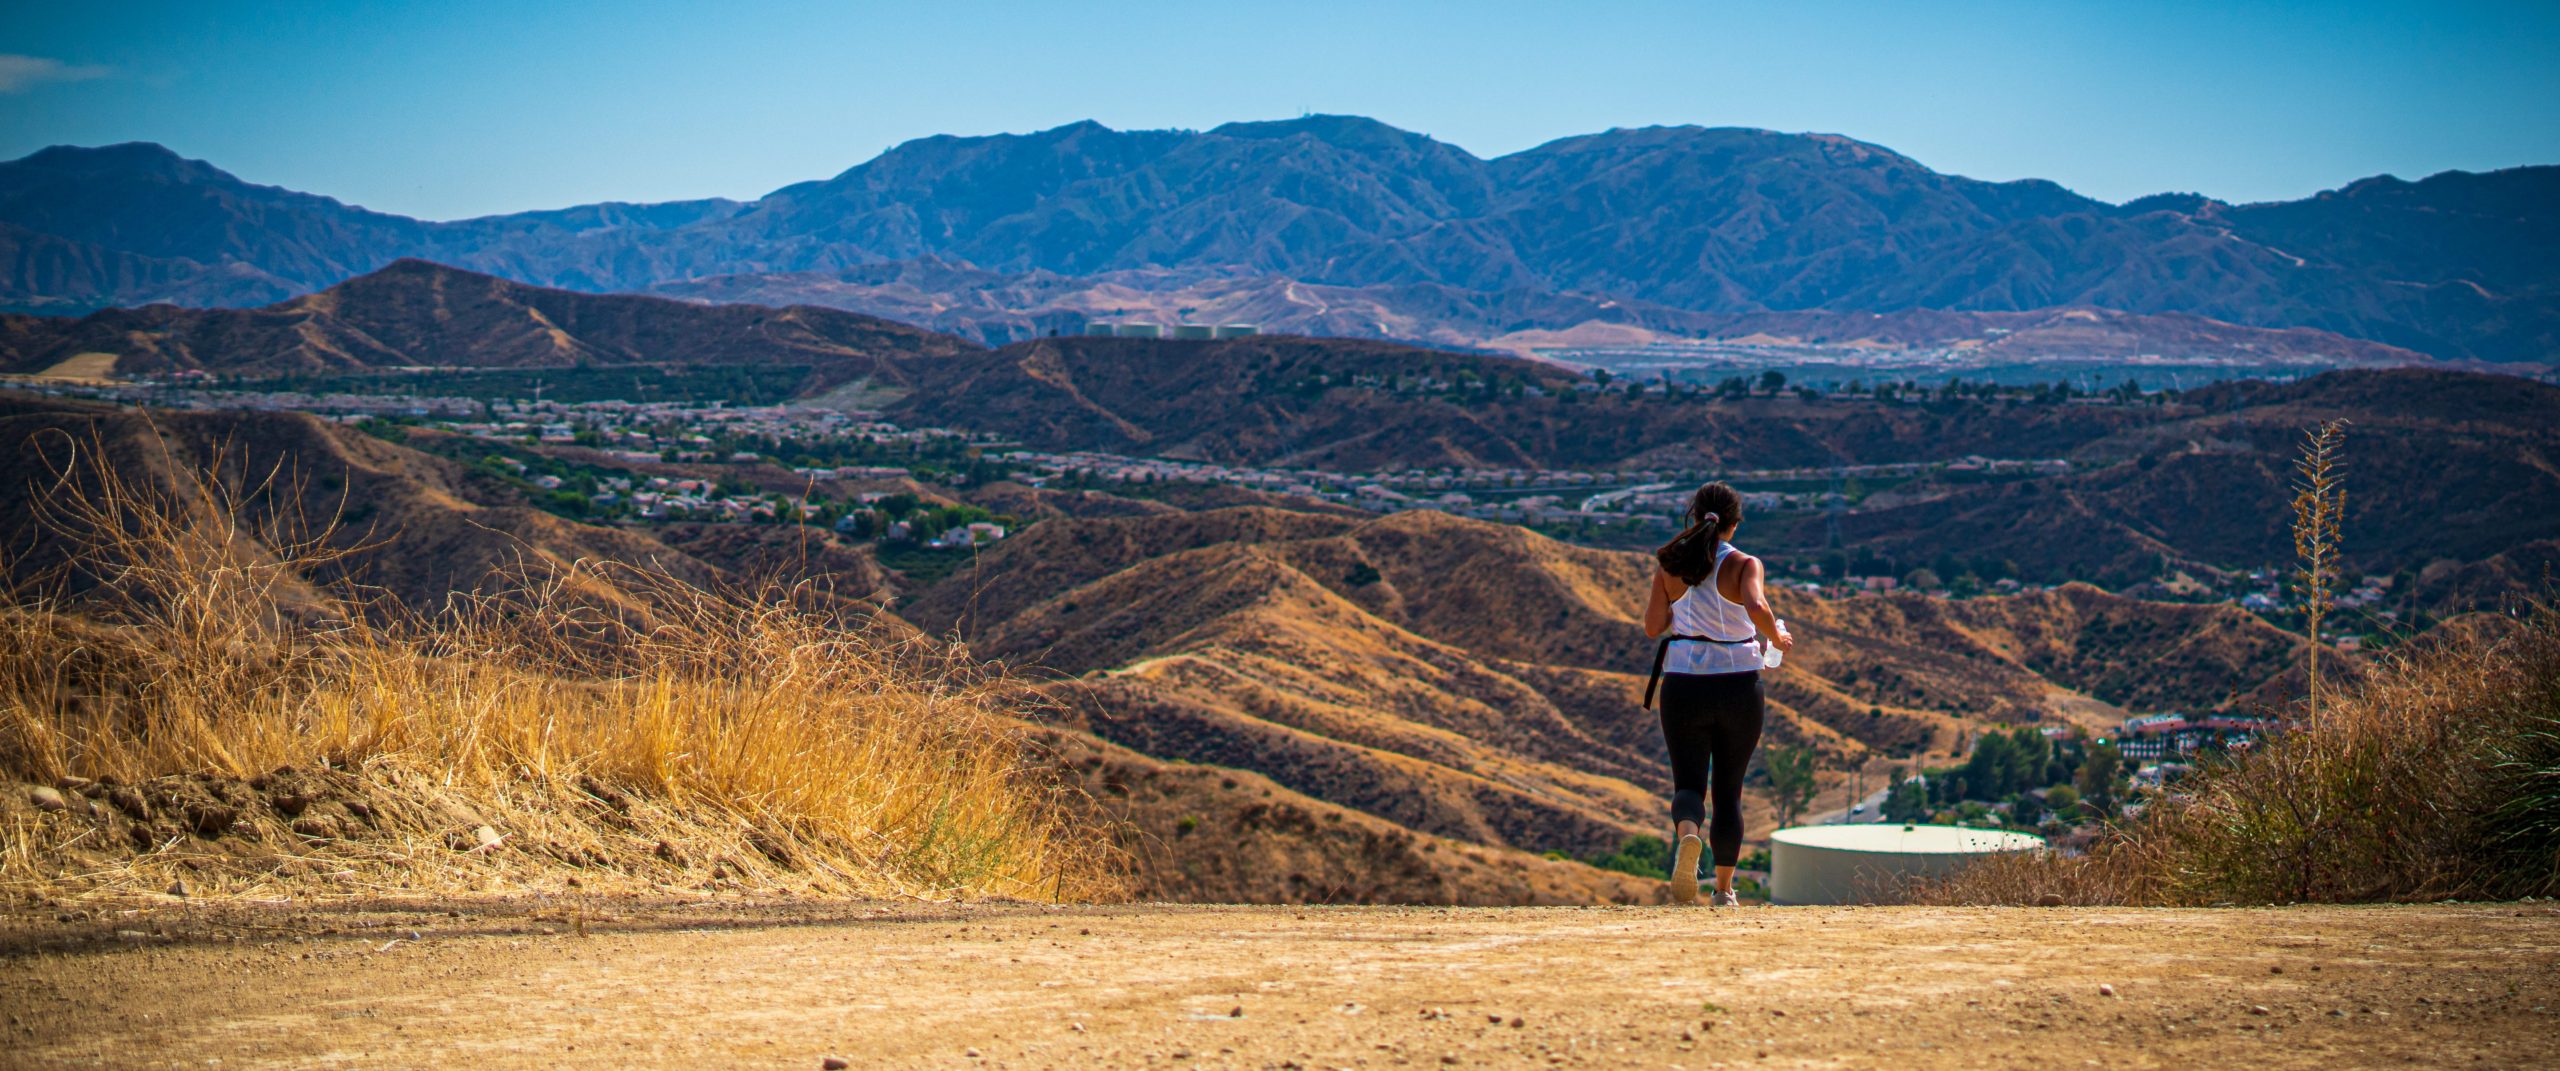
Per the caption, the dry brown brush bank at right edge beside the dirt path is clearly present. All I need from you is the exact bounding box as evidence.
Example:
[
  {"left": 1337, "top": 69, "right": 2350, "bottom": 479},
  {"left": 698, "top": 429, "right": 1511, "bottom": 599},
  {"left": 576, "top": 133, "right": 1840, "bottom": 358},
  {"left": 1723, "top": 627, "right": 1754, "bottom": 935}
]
[{"left": 1912, "top": 602, "right": 2560, "bottom": 907}]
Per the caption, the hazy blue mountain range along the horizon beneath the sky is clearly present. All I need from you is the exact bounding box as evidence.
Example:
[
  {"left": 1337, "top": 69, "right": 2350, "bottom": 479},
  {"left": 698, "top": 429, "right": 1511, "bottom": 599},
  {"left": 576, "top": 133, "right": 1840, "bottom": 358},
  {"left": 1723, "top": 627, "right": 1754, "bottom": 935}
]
[{"left": 0, "top": 115, "right": 2560, "bottom": 361}]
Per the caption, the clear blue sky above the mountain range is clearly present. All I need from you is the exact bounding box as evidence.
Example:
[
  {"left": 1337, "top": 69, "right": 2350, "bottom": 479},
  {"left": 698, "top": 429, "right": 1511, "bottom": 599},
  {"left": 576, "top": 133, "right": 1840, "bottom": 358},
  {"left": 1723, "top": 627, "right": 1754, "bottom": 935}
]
[{"left": 0, "top": 0, "right": 2560, "bottom": 218}]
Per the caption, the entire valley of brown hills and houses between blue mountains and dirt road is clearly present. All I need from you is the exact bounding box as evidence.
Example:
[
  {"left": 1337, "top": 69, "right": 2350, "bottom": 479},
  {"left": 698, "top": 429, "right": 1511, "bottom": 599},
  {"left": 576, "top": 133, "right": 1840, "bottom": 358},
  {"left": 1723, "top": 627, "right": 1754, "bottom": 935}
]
[{"left": 0, "top": 261, "right": 2560, "bottom": 902}]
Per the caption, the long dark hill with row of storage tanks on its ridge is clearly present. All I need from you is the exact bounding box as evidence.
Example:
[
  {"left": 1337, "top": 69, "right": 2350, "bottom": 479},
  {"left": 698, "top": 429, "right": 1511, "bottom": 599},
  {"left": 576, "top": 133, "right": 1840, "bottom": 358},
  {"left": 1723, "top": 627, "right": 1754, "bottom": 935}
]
[{"left": 891, "top": 336, "right": 2163, "bottom": 471}]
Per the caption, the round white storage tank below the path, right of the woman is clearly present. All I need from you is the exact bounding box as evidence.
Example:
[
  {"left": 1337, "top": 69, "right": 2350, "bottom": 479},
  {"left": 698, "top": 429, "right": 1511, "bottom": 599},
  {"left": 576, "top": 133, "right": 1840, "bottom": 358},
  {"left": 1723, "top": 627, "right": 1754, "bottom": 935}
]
[{"left": 1769, "top": 822, "right": 2045, "bottom": 904}]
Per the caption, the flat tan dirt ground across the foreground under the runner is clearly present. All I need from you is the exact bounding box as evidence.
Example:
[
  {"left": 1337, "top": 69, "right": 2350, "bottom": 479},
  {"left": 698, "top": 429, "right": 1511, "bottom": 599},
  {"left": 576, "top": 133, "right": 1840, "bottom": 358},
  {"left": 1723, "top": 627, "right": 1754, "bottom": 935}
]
[{"left": 0, "top": 902, "right": 2560, "bottom": 1071}]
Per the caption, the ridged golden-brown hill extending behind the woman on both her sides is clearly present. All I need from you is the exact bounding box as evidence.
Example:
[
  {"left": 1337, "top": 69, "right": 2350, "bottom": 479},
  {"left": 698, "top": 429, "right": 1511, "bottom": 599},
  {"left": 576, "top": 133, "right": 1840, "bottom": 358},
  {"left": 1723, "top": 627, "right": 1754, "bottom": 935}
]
[{"left": 901, "top": 510, "right": 2296, "bottom": 851}]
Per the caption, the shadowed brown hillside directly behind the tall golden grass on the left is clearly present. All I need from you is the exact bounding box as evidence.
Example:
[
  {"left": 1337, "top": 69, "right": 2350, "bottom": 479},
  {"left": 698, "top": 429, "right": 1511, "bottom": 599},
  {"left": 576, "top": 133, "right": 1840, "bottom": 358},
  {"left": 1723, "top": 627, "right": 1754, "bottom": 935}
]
[{"left": 0, "top": 395, "right": 906, "bottom": 630}]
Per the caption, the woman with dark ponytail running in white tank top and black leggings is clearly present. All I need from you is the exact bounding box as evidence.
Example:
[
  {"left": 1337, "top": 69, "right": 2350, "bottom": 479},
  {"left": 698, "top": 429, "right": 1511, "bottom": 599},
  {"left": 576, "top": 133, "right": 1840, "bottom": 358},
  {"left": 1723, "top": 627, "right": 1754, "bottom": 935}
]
[{"left": 1644, "top": 482, "right": 1795, "bottom": 907}]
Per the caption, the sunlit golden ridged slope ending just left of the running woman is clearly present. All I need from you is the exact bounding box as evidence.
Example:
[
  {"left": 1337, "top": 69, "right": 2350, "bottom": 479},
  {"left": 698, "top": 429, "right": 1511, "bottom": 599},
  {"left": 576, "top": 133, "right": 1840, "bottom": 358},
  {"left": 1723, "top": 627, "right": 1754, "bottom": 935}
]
[{"left": 973, "top": 543, "right": 1651, "bottom": 848}]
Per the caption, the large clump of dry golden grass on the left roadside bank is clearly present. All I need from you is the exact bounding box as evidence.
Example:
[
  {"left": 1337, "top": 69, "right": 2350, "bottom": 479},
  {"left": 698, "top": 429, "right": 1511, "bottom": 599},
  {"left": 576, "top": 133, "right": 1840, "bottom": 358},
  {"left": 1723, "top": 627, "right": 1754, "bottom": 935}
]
[{"left": 0, "top": 427, "right": 1114, "bottom": 899}]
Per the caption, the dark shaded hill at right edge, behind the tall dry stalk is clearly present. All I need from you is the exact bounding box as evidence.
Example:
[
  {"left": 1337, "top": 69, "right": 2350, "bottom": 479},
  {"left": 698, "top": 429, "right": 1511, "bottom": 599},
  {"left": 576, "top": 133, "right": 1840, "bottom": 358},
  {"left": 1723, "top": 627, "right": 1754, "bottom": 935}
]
[{"left": 1764, "top": 372, "right": 2560, "bottom": 586}]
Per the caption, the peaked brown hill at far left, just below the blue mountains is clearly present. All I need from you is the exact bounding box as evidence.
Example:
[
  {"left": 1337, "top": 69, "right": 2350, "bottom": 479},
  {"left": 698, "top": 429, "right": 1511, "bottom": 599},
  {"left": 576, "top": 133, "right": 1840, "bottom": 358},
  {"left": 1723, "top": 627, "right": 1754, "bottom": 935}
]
[{"left": 0, "top": 261, "right": 973, "bottom": 376}]
